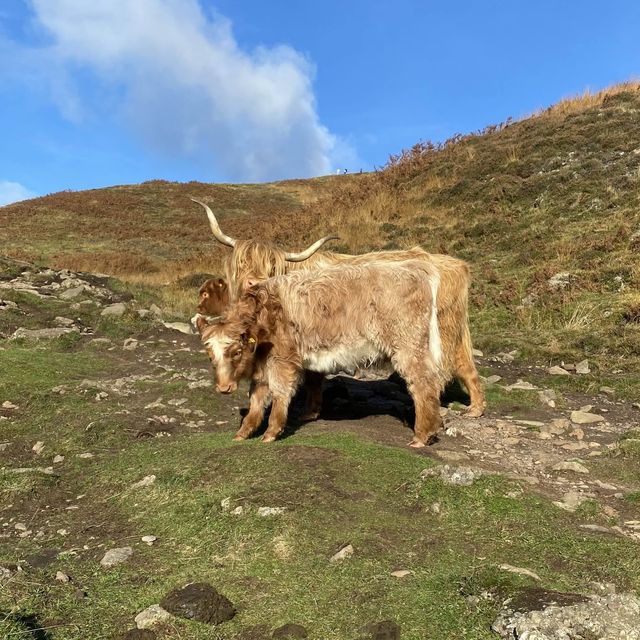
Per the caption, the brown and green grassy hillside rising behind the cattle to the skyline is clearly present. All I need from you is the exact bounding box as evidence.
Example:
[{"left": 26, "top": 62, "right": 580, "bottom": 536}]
[{"left": 0, "top": 84, "right": 640, "bottom": 386}]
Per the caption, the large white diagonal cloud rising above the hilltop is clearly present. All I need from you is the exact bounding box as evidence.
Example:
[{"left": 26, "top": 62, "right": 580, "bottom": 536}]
[{"left": 22, "top": 0, "right": 355, "bottom": 180}]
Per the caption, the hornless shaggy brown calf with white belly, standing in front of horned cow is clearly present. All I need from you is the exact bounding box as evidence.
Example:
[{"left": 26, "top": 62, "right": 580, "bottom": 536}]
[{"left": 202, "top": 260, "right": 465, "bottom": 447}]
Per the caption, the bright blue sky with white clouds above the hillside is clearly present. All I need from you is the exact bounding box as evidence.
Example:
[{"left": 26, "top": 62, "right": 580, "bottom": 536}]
[{"left": 0, "top": 0, "right": 640, "bottom": 204}]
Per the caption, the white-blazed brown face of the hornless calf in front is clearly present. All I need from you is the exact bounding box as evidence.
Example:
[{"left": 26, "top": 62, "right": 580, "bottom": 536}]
[{"left": 202, "top": 322, "right": 256, "bottom": 393}]
